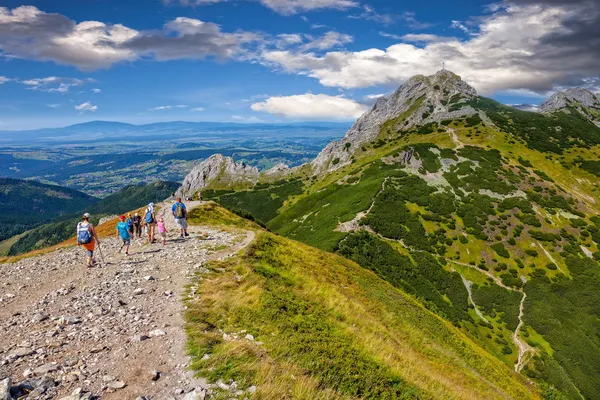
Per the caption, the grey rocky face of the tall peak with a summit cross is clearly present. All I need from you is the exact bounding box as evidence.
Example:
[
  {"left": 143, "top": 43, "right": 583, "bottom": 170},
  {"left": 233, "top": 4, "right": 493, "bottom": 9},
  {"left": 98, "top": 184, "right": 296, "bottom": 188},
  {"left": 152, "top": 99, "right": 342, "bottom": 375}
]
[{"left": 311, "top": 70, "right": 477, "bottom": 174}]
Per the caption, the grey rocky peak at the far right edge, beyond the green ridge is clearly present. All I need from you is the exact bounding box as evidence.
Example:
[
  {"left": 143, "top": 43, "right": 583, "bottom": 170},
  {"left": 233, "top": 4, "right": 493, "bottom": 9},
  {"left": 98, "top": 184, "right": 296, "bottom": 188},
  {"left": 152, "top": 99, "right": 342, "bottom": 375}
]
[{"left": 540, "top": 88, "right": 600, "bottom": 127}]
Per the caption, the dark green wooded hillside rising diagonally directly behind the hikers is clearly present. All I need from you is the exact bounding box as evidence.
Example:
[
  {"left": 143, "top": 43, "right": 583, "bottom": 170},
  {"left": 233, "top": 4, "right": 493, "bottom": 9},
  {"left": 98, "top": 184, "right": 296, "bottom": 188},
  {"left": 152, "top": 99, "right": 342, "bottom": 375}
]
[{"left": 8, "top": 182, "right": 179, "bottom": 255}]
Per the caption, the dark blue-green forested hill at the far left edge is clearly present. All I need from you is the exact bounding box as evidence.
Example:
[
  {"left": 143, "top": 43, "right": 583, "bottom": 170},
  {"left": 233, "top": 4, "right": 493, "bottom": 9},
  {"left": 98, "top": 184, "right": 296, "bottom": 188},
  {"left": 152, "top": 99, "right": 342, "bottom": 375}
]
[{"left": 0, "top": 179, "right": 97, "bottom": 241}]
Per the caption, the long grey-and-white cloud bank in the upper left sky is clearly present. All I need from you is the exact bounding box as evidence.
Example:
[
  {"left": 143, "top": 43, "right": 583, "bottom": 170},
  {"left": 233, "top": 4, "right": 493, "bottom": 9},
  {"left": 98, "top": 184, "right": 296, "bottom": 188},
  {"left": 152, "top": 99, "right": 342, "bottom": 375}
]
[{"left": 0, "top": 6, "right": 262, "bottom": 71}]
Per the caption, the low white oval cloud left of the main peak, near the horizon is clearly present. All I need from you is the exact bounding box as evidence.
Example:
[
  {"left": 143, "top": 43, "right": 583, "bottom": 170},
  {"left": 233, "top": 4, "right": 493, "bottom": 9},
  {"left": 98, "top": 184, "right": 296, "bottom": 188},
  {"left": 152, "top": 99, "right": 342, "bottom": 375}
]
[{"left": 251, "top": 93, "right": 368, "bottom": 120}]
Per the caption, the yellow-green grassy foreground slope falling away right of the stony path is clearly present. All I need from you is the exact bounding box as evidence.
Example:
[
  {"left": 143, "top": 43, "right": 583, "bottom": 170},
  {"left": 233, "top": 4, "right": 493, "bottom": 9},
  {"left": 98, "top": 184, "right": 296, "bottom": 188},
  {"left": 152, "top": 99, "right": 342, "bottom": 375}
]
[{"left": 187, "top": 205, "right": 539, "bottom": 399}]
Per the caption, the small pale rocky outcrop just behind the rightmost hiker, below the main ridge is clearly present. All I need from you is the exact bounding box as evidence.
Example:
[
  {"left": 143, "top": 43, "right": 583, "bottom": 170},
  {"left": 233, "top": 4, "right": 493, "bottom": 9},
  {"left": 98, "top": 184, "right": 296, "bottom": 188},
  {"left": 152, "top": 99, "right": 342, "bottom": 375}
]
[{"left": 177, "top": 154, "right": 260, "bottom": 197}]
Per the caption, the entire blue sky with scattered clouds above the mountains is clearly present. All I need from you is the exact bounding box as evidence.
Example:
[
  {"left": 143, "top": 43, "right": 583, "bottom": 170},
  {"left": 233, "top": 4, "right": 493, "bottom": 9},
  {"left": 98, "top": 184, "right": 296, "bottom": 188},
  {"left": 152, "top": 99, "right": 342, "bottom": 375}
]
[{"left": 0, "top": 0, "right": 600, "bottom": 130}]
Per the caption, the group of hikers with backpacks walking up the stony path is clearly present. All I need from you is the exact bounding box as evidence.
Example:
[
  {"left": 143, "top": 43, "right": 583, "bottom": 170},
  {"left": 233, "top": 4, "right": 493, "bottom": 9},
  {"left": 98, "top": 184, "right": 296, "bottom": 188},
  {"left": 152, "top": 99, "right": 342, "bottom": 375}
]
[{"left": 77, "top": 196, "right": 189, "bottom": 267}]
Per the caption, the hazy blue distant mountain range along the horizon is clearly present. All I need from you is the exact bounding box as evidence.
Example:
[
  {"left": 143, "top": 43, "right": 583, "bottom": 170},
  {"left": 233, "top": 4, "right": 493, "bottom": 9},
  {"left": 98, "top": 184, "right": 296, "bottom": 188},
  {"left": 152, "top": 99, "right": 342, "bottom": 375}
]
[{"left": 0, "top": 121, "right": 350, "bottom": 145}]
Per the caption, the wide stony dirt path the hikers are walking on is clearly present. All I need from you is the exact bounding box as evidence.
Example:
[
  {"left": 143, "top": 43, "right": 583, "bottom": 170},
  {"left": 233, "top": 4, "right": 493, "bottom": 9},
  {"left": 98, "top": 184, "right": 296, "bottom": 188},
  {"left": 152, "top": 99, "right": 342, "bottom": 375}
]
[{"left": 0, "top": 202, "right": 254, "bottom": 400}]
